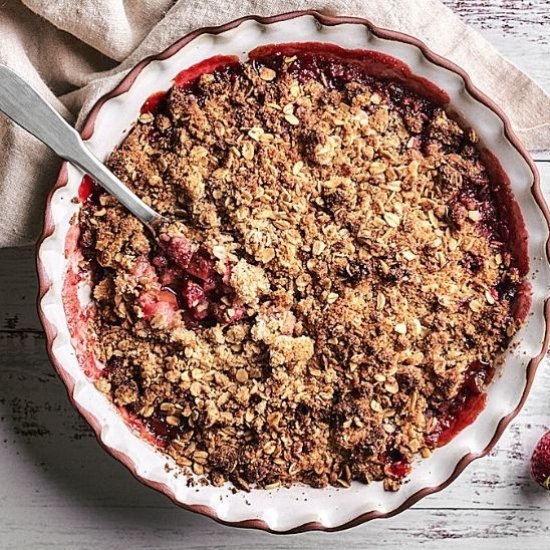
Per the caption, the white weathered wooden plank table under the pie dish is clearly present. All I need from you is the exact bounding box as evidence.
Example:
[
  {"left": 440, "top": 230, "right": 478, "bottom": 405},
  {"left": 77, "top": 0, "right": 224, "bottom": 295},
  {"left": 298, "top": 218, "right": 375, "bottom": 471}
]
[{"left": 0, "top": 0, "right": 550, "bottom": 550}]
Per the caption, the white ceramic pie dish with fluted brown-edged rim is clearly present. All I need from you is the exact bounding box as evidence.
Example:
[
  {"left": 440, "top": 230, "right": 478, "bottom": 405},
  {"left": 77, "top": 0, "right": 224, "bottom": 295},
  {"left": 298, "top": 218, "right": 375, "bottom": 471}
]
[{"left": 37, "top": 12, "right": 550, "bottom": 532}]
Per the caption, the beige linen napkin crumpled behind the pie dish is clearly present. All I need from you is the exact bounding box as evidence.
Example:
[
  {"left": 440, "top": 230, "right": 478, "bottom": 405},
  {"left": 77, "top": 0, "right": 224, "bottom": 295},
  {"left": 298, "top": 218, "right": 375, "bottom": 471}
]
[{"left": 0, "top": 0, "right": 550, "bottom": 247}]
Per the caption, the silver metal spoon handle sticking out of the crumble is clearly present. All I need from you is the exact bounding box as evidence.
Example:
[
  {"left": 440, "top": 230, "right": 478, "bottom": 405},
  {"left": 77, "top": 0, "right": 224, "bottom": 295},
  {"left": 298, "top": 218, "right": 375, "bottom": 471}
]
[{"left": 0, "top": 64, "right": 166, "bottom": 235}]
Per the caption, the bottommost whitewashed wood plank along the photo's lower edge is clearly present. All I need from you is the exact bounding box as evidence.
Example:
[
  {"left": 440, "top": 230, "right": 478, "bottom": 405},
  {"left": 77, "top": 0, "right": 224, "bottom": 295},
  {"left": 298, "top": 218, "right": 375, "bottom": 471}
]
[{"left": 0, "top": 508, "right": 550, "bottom": 550}]
